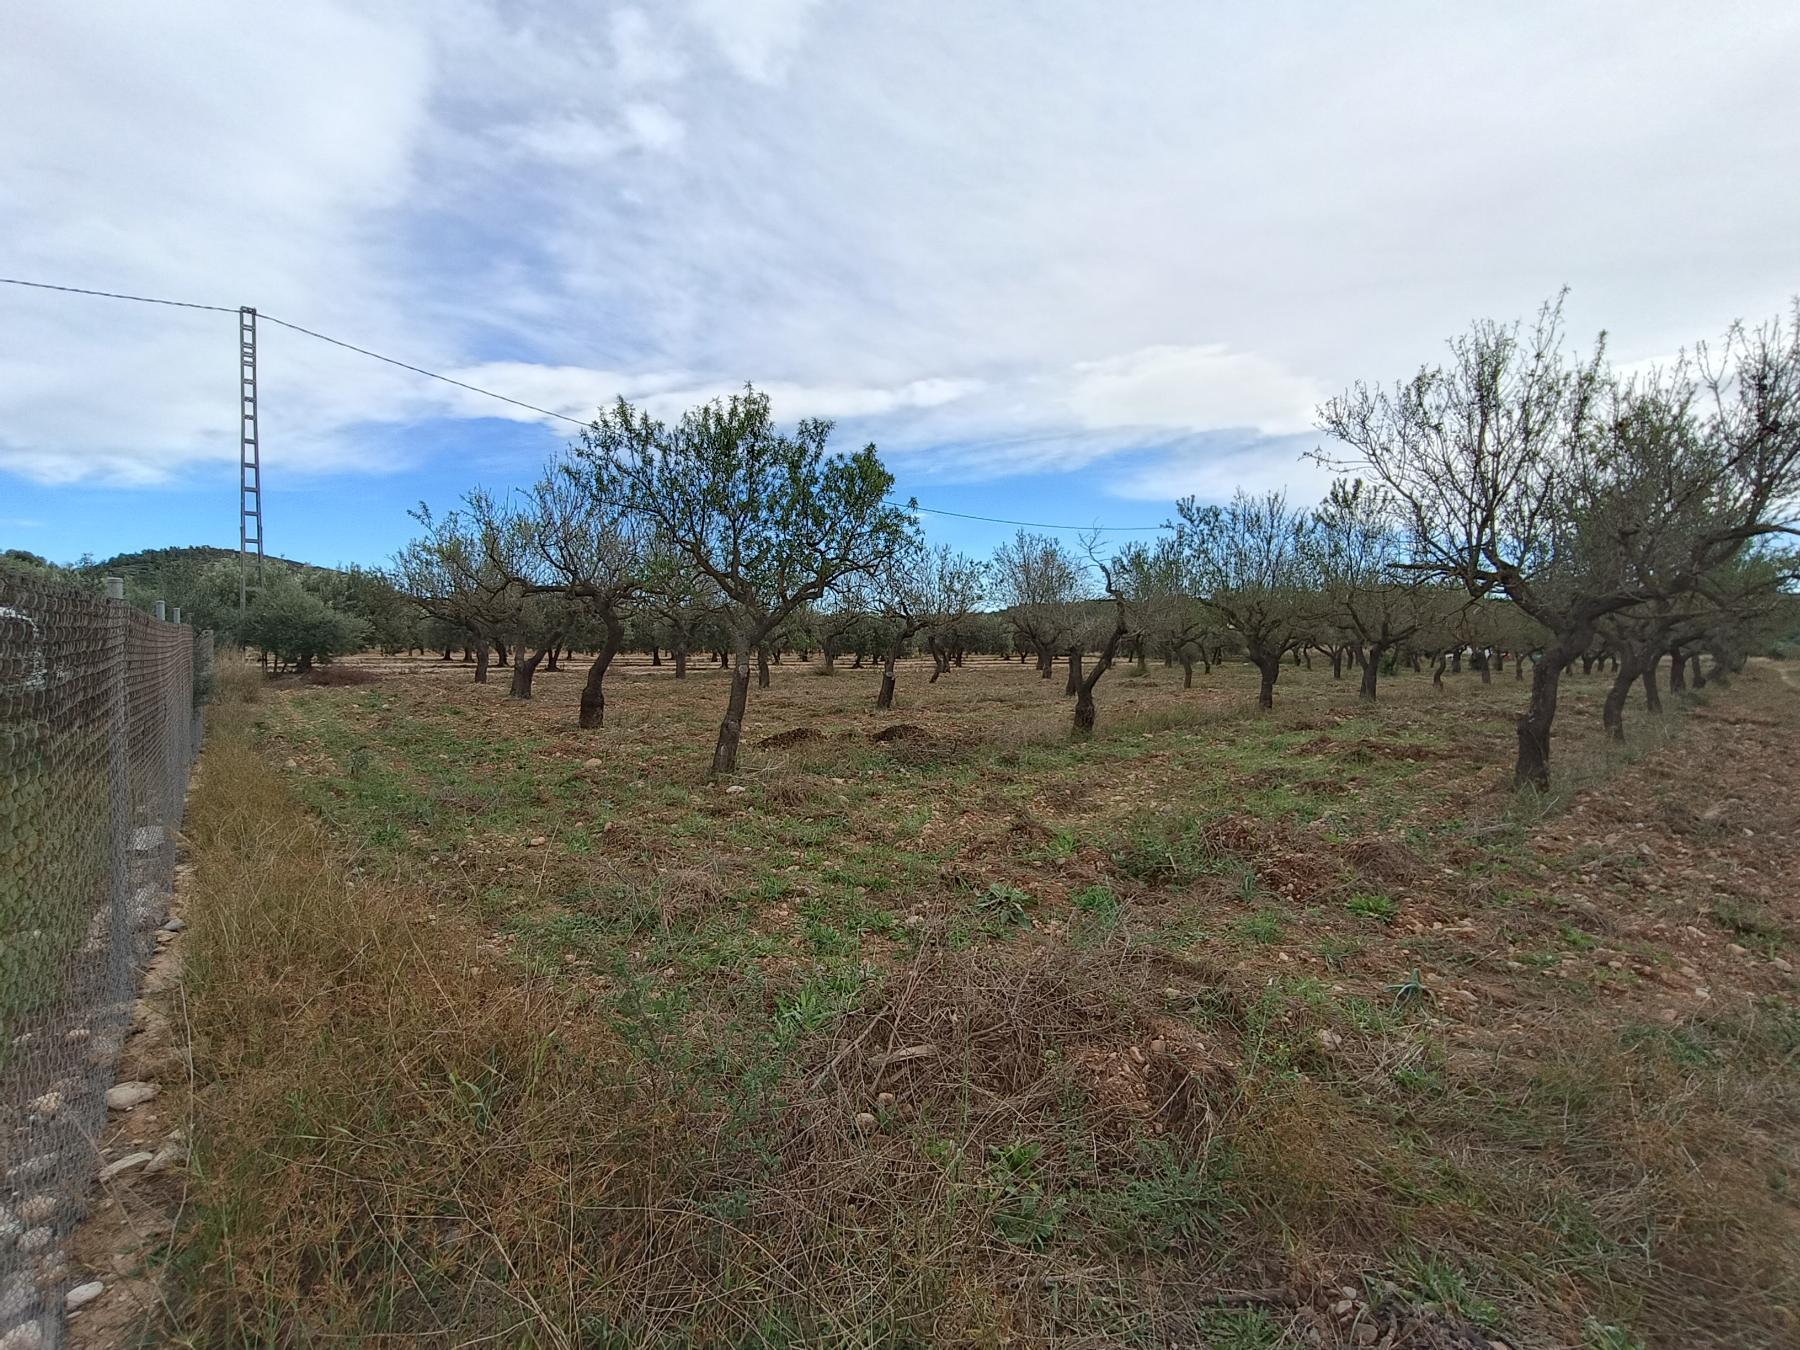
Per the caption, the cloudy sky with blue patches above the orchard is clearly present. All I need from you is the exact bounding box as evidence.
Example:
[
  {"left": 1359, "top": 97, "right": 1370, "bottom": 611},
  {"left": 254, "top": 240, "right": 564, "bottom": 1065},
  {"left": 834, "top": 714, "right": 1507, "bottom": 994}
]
[{"left": 0, "top": 0, "right": 1800, "bottom": 563}]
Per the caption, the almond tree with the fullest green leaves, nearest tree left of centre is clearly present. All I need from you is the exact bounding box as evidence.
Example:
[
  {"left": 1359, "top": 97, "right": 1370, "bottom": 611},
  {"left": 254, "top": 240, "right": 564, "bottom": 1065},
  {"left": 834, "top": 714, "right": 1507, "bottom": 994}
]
[{"left": 576, "top": 387, "right": 913, "bottom": 774}]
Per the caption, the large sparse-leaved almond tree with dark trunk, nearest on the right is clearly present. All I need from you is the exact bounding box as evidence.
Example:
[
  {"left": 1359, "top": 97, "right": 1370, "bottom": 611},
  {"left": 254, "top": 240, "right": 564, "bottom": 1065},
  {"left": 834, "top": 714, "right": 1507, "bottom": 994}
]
[{"left": 1319, "top": 297, "right": 1800, "bottom": 788}]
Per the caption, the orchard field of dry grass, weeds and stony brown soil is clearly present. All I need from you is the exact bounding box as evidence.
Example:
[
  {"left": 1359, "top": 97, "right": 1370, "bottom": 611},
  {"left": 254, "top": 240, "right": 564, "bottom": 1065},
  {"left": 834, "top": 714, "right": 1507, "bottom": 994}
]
[{"left": 171, "top": 657, "right": 1800, "bottom": 1350}]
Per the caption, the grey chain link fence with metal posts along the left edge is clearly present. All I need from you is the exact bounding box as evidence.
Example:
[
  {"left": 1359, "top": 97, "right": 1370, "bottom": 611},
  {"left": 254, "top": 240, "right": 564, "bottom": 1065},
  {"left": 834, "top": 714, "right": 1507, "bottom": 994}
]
[{"left": 0, "top": 569, "right": 209, "bottom": 1350}]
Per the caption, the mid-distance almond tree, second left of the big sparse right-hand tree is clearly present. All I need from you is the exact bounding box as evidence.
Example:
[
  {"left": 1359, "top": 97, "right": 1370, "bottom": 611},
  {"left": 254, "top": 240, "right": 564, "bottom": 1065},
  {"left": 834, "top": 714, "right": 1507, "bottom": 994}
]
[{"left": 1174, "top": 490, "right": 1319, "bottom": 709}]
